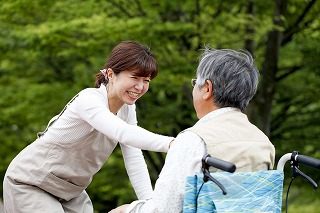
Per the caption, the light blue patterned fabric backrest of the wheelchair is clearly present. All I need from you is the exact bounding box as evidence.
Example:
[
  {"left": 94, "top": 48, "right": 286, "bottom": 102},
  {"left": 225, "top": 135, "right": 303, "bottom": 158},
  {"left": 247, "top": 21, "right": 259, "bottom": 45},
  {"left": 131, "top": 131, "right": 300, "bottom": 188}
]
[{"left": 183, "top": 170, "right": 284, "bottom": 213}]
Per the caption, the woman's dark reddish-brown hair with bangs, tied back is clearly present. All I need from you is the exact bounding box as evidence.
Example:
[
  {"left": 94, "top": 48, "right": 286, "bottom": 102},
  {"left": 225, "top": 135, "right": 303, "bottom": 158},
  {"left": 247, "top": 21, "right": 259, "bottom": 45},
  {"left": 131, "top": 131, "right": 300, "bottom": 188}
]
[{"left": 95, "top": 41, "right": 158, "bottom": 88}]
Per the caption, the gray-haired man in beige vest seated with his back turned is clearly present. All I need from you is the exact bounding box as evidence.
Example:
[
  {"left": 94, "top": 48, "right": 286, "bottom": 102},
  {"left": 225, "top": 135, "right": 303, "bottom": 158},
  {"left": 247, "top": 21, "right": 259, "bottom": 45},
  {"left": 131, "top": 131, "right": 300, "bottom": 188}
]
[{"left": 112, "top": 47, "right": 275, "bottom": 213}]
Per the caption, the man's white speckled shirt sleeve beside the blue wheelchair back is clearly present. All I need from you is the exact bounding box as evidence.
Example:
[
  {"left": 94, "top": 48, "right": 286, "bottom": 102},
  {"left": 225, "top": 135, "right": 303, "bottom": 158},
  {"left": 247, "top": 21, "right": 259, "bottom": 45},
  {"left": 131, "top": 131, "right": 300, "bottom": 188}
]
[{"left": 127, "top": 131, "right": 205, "bottom": 213}]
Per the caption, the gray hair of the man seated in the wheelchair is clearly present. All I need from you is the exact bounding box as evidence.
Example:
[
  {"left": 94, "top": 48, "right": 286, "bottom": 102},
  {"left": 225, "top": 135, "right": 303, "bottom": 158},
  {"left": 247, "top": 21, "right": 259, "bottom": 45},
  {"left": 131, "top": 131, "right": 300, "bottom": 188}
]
[{"left": 196, "top": 46, "right": 259, "bottom": 111}]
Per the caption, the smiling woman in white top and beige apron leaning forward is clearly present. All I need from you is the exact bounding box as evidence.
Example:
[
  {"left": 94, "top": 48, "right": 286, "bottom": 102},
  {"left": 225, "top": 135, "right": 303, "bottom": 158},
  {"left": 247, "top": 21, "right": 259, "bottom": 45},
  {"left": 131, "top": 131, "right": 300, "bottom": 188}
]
[{"left": 3, "top": 41, "right": 173, "bottom": 213}]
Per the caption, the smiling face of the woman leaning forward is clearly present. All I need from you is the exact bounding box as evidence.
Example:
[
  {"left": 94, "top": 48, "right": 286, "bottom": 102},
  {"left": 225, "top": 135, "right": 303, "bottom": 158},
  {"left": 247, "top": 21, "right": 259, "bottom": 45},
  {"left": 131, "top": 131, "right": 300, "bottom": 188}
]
[{"left": 108, "top": 70, "right": 150, "bottom": 105}]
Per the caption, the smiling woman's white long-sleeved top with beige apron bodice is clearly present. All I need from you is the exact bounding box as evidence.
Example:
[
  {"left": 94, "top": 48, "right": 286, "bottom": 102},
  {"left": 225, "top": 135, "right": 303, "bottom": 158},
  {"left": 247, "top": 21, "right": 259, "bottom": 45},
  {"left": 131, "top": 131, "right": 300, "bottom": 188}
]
[{"left": 6, "top": 85, "right": 173, "bottom": 200}]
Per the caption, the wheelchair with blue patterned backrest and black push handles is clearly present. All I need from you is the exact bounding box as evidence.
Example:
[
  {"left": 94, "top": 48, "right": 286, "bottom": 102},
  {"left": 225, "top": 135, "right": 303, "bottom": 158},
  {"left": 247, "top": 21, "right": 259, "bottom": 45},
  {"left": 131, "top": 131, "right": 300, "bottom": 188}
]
[{"left": 183, "top": 151, "right": 320, "bottom": 213}]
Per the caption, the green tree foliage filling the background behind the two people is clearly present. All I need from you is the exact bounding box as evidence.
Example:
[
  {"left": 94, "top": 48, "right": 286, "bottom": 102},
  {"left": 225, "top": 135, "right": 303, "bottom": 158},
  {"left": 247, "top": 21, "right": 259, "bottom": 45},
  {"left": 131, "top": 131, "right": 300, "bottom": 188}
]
[{"left": 0, "top": 0, "right": 320, "bottom": 212}]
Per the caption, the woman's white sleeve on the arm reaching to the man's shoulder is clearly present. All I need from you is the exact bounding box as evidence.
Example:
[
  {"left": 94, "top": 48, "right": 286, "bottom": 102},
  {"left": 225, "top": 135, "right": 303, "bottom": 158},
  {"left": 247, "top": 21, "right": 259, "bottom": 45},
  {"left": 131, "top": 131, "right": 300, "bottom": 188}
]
[{"left": 76, "top": 92, "right": 174, "bottom": 152}]
